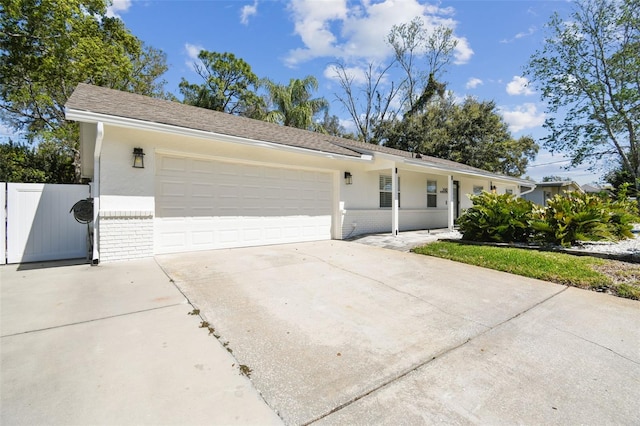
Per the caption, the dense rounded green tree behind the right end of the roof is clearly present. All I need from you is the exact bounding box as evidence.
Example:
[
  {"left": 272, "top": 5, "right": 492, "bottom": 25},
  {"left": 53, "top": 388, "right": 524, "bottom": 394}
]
[{"left": 385, "top": 97, "right": 538, "bottom": 177}]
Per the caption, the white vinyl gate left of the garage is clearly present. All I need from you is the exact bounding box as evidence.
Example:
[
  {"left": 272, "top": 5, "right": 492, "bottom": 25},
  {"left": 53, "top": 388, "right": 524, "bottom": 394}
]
[{"left": 0, "top": 183, "right": 89, "bottom": 263}]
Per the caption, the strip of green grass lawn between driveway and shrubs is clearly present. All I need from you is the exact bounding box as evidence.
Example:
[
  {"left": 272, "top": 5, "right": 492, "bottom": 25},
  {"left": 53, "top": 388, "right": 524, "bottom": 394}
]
[{"left": 413, "top": 241, "right": 640, "bottom": 300}]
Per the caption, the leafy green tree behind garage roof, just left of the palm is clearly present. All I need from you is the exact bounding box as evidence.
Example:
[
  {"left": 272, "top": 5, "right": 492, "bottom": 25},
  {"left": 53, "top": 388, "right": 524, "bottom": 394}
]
[{"left": 180, "top": 50, "right": 265, "bottom": 118}]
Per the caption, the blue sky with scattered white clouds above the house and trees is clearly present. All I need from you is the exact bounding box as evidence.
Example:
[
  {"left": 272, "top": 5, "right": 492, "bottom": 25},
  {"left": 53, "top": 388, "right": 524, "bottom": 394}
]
[{"left": 110, "top": 0, "right": 601, "bottom": 184}]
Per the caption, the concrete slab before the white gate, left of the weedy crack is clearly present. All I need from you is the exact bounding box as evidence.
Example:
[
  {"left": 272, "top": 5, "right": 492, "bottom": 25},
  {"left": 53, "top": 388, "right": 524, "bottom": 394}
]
[{"left": 0, "top": 259, "right": 281, "bottom": 425}]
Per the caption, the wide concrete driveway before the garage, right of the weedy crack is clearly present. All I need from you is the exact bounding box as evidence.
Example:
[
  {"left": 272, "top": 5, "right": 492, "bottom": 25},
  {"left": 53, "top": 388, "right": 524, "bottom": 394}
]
[{"left": 157, "top": 241, "right": 640, "bottom": 425}]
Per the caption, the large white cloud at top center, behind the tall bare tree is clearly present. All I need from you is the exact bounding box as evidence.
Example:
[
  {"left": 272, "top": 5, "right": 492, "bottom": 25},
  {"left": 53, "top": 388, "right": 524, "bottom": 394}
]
[{"left": 286, "top": 0, "right": 473, "bottom": 66}]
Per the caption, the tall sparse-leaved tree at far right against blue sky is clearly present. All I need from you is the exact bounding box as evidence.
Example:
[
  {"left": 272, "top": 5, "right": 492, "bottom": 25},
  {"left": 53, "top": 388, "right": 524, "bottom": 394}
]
[{"left": 526, "top": 0, "right": 640, "bottom": 188}]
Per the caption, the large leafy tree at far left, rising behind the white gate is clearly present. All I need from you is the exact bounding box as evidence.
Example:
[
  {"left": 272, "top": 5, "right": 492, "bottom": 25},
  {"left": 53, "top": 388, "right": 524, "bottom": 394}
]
[{"left": 0, "top": 0, "right": 167, "bottom": 180}]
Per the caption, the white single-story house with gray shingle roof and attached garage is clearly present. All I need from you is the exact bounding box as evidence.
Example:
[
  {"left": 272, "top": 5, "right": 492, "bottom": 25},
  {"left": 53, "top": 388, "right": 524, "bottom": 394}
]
[{"left": 66, "top": 84, "right": 535, "bottom": 263}]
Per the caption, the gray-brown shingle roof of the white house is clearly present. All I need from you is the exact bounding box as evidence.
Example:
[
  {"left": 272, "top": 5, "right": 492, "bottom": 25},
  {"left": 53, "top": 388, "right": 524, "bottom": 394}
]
[{"left": 65, "top": 83, "right": 522, "bottom": 181}]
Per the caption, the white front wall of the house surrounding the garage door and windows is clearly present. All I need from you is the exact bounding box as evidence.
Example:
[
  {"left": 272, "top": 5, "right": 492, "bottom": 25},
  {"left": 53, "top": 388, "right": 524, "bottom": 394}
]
[{"left": 90, "top": 120, "right": 528, "bottom": 260}]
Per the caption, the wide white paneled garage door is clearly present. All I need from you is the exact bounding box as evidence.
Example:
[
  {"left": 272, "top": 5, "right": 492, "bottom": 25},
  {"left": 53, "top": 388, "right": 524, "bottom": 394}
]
[{"left": 155, "top": 156, "right": 332, "bottom": 253}]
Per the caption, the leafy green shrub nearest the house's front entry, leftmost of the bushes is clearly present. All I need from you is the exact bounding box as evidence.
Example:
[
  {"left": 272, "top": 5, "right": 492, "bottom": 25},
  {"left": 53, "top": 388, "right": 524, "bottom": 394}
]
[{"left": 458, "top": 191, "right": 533, "bottom": 242}]
